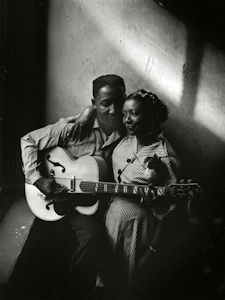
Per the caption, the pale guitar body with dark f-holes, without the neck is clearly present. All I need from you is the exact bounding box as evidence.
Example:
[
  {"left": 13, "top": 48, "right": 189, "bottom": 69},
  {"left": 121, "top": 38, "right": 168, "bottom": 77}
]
[{"left": 25, "top": 147, "right": 107, "bottom": 221}]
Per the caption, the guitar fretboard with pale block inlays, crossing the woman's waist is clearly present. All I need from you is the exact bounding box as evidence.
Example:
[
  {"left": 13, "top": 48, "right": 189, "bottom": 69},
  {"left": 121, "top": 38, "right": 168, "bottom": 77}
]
[{"left": 79, "top": 181, "right": 151, "bottom": 196}]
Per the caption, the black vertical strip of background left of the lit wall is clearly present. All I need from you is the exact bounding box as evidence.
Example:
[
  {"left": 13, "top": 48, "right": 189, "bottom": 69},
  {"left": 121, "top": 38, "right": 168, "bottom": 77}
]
[{"left": 0, "top": 0, "right": 48, "bottom": 217}]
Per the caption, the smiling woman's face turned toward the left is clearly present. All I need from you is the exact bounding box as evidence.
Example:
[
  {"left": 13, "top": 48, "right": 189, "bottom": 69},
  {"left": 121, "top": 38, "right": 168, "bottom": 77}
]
[{"left": 122, "top": 99, "right": 152, "bottom": 136}]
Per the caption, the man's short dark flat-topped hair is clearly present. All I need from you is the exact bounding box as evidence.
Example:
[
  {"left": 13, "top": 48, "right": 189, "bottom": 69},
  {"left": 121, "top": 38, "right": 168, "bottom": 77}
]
[{"left": 92, "top": 74, "right": 125, "bottom": 98}]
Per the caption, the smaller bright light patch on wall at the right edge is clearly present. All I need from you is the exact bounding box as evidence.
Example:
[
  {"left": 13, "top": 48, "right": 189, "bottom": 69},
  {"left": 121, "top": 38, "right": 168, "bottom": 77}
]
[{"left": 193, "top": 44, "right": 225, "bottom": 141}]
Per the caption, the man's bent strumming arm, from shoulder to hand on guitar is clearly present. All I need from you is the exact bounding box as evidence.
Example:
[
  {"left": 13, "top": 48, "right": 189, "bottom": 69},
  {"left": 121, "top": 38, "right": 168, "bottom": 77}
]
[{"left": 21, "top": 106, "right": 95, "bottom": 195}]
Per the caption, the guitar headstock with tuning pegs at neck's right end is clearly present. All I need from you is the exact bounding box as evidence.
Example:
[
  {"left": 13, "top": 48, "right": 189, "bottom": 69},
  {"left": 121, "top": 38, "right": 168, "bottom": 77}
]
[{"left": 167, "top": 180, "right": 202, "bottom": 199}]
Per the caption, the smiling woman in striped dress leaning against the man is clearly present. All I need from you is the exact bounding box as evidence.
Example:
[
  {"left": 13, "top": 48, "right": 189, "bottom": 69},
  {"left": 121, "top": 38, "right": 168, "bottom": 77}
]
[{"left": 106, "top": 90, "right": 180, "bottom": 289}]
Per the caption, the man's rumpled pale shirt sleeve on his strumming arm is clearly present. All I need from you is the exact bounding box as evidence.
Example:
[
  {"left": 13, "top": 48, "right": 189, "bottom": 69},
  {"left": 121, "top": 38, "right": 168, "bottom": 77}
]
[{"left": 21, "top": 118, "right": 74, "bottom": 184}]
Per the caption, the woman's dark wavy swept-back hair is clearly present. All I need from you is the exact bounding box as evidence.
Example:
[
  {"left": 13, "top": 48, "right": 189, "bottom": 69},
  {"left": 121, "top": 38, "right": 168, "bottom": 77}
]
[{"left": 125, "top": 89, "right": 168, "bottom": 126}]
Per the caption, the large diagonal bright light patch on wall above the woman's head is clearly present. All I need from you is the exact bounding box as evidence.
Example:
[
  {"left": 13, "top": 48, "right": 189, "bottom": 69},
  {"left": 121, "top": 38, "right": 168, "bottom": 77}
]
[{"left": 78, "top": 0, "right": 186, "bottom": 105}]
